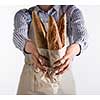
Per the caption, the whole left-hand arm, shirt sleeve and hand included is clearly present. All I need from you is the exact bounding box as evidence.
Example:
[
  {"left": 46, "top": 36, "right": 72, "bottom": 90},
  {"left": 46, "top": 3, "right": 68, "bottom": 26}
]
[{"left": 13, "top": 10, "right": 49, "bottom": 71}]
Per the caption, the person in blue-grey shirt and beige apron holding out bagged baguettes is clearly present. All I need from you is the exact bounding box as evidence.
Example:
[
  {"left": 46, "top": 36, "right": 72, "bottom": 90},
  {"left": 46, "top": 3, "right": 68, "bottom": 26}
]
[{"left": 13, "top": 5, "right": 87, "bottom": 95}]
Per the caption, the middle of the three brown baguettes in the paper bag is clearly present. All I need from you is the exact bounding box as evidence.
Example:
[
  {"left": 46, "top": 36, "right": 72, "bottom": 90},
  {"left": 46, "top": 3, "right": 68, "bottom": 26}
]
[{"left": 47, "top": 16, "right": 62, "bottom": 50}]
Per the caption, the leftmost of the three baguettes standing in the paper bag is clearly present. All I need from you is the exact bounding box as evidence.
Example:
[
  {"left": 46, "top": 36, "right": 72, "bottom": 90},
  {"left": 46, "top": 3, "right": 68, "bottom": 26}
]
[{"left": 32, "top": 11, "right": 47, "bottom": 49}]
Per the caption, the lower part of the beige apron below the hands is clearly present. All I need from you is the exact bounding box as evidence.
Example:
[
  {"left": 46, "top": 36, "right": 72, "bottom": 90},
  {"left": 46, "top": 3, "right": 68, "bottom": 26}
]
[{"left": 17, "top": 54, "right": 75, "bottom": 95}]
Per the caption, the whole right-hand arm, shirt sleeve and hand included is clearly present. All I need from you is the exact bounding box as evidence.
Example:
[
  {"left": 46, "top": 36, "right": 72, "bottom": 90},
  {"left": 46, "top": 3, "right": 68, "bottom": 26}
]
[{"left": 54, "top": 8, "right": 87, "bottom": 74}]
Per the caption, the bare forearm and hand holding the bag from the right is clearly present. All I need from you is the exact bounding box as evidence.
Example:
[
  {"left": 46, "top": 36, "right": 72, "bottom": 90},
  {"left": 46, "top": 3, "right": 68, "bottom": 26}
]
[{"left": 52, "top": 43, "right": 80, "bottom": 75}]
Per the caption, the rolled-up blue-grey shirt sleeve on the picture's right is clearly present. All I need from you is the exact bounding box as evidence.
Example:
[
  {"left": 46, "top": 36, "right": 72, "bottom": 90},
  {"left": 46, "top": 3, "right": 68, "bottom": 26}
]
[{"left": 71, "top": 8, "right": 88, "bottom": 53}]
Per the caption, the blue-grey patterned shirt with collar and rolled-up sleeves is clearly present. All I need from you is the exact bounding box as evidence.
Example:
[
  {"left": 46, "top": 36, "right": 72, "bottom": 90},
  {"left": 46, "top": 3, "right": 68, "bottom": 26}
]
[{"left": 13, "top": 5, "right": 87, "bottom": 54}]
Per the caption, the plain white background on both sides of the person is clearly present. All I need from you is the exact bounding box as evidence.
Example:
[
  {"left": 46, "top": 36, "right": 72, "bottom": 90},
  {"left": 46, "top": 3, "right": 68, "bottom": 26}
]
[{"left": 0, "top": 4, "right": 100, "bottom": 94}]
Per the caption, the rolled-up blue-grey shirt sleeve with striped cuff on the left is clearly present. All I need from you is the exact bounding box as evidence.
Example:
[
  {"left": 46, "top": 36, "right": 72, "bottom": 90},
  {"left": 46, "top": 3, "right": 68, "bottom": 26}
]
[{"left": 13, "top": 9, "right": 30, "bottom": 51}]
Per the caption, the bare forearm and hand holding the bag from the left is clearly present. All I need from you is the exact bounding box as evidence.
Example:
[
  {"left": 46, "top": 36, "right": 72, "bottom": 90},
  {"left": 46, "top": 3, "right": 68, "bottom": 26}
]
[{"left": 25, "top": 40, "right": 49, "bottom": 72}]
